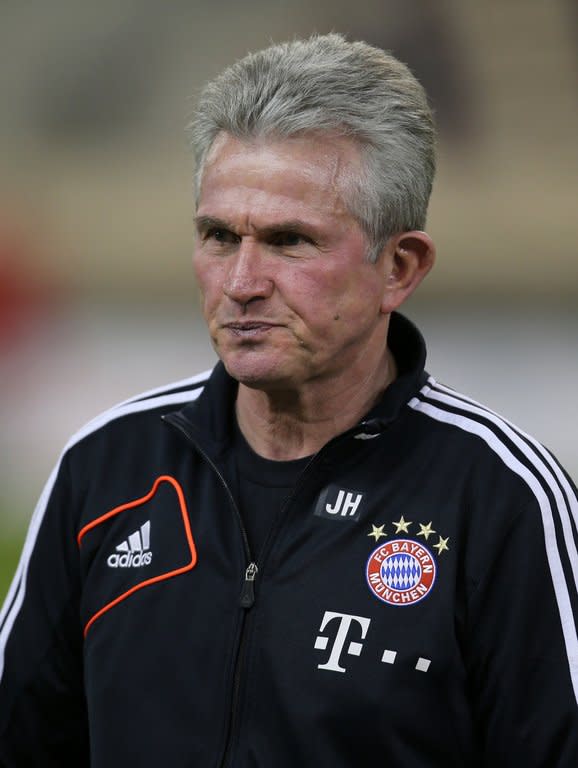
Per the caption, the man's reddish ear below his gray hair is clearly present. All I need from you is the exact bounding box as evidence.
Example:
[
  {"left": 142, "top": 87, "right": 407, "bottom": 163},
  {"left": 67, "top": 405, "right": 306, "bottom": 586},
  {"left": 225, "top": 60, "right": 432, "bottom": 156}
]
[{"left": 379, "top": 230, "right": 436, "bottom": 314}]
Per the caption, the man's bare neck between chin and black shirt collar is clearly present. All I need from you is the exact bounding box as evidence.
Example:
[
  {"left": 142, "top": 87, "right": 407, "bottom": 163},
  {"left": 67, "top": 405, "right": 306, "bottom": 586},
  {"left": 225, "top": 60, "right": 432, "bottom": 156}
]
[{"left": 236, "top": 350, "right": 397, "bottom": 461}]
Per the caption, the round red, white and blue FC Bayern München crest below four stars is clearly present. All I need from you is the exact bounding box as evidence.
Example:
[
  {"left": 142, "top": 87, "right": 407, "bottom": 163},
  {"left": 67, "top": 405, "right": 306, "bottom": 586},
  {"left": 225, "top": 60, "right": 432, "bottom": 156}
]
[{"left": 366, "top": 539, "right": 436, "bottom": 606}]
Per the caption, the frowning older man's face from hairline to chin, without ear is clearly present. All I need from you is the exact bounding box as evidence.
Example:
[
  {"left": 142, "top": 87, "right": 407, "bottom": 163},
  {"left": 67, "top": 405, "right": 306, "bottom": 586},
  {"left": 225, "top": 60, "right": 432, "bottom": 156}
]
[{"left": 194, "top": 135, "right": 387, "bottom": 390}]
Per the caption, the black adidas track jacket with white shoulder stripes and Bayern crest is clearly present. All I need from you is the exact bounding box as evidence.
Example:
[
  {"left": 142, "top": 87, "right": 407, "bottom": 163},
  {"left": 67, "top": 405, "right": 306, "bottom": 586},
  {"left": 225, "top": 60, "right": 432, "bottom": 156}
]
[{"left": 0, "top": 315, "right": 578, "bottom": 768}]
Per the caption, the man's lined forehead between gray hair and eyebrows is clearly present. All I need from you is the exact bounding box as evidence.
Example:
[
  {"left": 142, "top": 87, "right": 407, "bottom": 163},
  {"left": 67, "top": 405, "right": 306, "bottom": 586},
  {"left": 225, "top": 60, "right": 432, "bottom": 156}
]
[{"left": 198, "top": 133, "right": 360, "bottom": 226}]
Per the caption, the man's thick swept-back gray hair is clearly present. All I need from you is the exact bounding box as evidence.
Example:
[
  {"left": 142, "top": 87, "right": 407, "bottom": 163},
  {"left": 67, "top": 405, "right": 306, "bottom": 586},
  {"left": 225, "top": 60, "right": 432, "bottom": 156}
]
[{"left": 189, "top": 34, "right": 435, "bottom": 260}]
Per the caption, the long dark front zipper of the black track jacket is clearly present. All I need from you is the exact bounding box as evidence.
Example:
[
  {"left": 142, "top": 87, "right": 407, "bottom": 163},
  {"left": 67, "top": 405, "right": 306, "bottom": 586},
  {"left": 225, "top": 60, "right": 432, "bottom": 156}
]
[{"left": 161, "top": 413, "right": 254, "bottom": 768}]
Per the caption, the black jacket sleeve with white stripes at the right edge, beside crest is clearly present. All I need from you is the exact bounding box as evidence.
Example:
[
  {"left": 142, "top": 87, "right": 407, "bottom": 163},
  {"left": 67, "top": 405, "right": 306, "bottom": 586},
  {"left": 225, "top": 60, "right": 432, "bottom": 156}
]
[{"left": 465, "top": 473, "right": 578, "bottom": 768}]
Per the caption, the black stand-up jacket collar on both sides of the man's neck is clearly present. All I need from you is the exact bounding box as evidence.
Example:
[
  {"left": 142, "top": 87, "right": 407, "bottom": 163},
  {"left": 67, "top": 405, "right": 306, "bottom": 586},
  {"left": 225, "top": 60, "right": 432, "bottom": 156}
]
[{"left": 171, "top": 312, "right": 427, "bottom": 456}]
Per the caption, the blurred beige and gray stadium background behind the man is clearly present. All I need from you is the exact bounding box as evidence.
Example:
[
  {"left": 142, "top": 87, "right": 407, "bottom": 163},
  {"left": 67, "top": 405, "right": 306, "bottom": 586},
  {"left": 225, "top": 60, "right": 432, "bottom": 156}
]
[{"left": 0, "top": 0, "right": 578, "bottom": 599}]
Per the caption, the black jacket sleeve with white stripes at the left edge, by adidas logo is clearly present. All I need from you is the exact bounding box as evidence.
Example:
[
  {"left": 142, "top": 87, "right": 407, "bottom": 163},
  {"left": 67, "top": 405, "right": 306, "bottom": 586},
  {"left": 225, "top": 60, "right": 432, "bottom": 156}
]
[{"left": 0, "top": 457, "right": 89, "bottom": 768}]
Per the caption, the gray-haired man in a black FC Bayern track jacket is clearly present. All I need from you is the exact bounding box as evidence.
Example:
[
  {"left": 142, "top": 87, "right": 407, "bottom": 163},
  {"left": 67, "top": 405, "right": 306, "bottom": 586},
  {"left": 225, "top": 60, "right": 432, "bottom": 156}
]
[{"left": 0, "top": 35, "right": 578, "bottom": 768}]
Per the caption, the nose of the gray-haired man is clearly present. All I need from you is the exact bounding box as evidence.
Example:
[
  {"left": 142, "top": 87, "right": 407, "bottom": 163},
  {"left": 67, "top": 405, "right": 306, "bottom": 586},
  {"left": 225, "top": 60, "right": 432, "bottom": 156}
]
[{"left": 223, "top": 238, "right": 274, "bottom": 305}]
